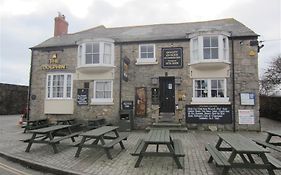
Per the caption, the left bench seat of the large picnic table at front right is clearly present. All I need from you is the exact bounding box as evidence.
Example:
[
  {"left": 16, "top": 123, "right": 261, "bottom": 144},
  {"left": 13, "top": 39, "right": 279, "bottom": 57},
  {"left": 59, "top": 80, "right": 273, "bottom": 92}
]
[{"left": 205, "top": 144, "right": 230, "bottom": 167}]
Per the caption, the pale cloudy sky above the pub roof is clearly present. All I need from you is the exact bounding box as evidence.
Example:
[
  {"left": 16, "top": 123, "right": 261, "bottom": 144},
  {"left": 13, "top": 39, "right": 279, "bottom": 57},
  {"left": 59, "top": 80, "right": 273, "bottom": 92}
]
[{"left": 0, "top": 0, "right": 281, "bottom": 85}]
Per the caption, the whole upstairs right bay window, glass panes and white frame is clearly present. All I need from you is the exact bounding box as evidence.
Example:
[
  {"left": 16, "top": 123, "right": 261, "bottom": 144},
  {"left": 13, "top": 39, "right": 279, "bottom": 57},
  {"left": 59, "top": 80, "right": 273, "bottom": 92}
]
[{"left": 190, "top": 35, "right": 229, "bottom": 63}]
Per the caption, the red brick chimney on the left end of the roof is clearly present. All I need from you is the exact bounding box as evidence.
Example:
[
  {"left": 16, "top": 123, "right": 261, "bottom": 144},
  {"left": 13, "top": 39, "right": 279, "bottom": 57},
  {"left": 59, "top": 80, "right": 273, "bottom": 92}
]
[{"left": 54, "top": 12, "right": 68, "bottom": 36}]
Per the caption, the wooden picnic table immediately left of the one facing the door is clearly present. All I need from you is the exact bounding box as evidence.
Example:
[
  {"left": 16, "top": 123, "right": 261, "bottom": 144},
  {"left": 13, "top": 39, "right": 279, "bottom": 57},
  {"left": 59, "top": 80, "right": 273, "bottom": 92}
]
[{"left": 75, "top": 126, "right": 128, "bottom": 159}]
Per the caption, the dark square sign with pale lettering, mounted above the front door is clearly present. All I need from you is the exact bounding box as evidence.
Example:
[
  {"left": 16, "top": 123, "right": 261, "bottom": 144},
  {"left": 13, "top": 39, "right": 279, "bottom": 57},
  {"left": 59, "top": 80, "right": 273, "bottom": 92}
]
[{"left": 161, "top": 47, "right": 183, "bottom": 69}]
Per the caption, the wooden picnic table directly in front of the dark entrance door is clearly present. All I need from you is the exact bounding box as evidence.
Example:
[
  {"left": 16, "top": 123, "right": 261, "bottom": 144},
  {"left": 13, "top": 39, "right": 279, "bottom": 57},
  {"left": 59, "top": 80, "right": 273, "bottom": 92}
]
[{"left": 131, "top": 129, "right": 185, "bottom": 168}]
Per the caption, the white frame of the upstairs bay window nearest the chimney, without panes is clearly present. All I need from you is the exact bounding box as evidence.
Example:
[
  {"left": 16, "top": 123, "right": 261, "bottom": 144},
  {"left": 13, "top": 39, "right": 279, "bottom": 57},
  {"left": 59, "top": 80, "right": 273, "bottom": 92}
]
[{"left": 77, "top": 39, "right": 114, "bottom": 67}]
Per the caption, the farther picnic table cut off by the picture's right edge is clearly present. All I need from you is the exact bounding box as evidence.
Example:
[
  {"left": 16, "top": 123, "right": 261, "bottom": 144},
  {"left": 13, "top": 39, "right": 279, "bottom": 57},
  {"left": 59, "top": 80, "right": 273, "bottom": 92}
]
[{"left": 253, "top": 130, "right": 281, "bottom": 152}]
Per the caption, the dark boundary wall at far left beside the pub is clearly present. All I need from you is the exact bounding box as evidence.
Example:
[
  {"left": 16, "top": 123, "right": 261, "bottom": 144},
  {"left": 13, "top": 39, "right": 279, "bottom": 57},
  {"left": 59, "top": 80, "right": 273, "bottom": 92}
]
[{"left": 0, "top": 83, "right": 28, "bottom": 115}]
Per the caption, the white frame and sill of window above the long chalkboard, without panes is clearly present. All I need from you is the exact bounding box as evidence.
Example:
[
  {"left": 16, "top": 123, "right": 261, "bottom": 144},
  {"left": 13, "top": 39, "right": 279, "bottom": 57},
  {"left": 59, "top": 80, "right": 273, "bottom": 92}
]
[{"left": 191, "top": 78, "right": 230, "bottom": 104}]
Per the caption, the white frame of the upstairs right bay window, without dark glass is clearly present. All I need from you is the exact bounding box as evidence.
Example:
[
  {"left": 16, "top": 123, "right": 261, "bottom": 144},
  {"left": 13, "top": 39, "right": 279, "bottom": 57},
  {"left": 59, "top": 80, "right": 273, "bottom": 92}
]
[{"left": 190, "top": 34, "right": 229, "bottom": 63}]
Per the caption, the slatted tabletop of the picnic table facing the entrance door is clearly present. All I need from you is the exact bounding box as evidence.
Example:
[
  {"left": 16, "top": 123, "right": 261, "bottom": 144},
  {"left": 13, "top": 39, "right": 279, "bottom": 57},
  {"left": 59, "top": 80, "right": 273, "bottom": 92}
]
[{"left": 144, "top": 129, "right": 170, "bottom": 144}]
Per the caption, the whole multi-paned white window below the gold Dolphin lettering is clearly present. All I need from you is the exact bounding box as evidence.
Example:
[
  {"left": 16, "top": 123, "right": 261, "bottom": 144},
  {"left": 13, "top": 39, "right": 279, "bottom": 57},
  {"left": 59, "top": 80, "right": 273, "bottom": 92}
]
[{"left": 46, "top": 73, "right": 73, "bottom": 99}]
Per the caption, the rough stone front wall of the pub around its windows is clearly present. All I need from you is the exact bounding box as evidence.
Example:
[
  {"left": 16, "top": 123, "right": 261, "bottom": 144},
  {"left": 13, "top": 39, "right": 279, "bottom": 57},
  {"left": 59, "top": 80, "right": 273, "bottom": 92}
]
[{"left": 30, "top": 37, "right": 260, "bottom": 130}]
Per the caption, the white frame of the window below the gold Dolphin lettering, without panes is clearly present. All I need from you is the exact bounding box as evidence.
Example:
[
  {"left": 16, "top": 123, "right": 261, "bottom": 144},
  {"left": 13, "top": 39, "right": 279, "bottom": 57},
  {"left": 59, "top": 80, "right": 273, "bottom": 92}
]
[{"left": 46, "top": 73, "right": 73, "bottom": 100}]
